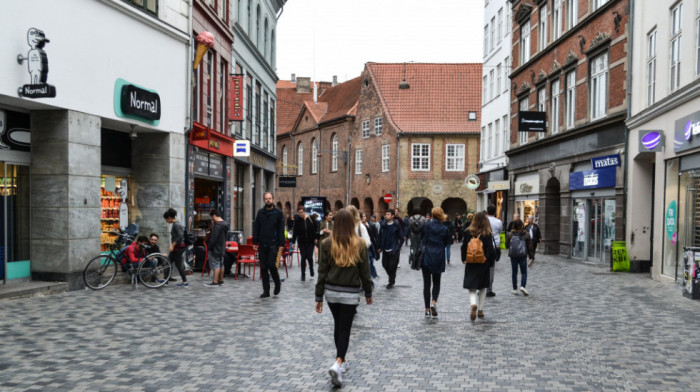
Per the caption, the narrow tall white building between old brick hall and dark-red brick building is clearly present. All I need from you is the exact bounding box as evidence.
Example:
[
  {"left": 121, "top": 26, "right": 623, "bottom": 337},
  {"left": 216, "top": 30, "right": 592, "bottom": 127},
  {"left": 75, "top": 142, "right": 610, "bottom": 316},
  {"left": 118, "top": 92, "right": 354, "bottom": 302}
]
[{"left": 478, "top": 0, "right": 512, "bottom": 220}]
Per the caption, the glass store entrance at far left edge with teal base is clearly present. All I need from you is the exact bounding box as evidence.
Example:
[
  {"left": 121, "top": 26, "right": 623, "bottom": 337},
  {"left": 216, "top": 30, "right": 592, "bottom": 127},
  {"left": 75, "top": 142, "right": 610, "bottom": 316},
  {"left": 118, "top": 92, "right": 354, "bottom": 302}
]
[{"left": 0, "top": 162, "right": 31, "bottom": 284}]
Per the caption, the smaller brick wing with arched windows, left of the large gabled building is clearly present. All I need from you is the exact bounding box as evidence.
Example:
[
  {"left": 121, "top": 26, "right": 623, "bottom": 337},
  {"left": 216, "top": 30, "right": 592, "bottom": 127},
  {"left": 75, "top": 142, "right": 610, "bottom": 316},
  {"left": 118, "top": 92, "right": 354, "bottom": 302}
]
[{"left": 275, "top": 77, "right": 360, "bottom": 214}]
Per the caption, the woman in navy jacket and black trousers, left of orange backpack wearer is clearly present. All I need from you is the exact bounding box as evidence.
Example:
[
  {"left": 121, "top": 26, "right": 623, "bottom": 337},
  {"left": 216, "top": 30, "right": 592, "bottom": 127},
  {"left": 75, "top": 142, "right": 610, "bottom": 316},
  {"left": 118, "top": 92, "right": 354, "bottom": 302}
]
[{"left": 421, "top": 207, "right": 452, "bottom": 318}]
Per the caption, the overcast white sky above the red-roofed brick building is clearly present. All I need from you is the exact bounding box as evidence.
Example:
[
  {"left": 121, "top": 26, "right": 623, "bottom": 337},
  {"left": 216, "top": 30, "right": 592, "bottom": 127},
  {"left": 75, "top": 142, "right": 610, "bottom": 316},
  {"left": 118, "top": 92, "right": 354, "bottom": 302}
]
[{"left": 277, "top": 0, "right": 484, "bottom": 82}]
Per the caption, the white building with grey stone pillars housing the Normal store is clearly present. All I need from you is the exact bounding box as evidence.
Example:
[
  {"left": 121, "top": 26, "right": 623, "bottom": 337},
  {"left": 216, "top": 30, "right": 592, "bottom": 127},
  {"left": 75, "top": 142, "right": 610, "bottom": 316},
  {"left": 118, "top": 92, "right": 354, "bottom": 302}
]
[{"left": 0, "top": 0, "right": 191, "bottom": 289}]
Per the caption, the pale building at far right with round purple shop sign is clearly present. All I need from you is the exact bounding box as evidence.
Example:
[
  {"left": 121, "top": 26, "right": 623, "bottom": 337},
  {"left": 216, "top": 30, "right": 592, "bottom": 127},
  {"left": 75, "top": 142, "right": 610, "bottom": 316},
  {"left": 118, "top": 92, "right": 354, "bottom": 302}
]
[{"left": 625, "top": 0, "right": 700, "bottom": 281}]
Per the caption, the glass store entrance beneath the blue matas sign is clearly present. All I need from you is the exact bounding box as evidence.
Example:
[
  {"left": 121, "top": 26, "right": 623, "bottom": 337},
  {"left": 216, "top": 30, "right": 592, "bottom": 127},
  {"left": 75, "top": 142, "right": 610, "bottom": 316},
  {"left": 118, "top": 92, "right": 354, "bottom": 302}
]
[{"left": 571, "top": 198, "right": 615, "bottom": 264}]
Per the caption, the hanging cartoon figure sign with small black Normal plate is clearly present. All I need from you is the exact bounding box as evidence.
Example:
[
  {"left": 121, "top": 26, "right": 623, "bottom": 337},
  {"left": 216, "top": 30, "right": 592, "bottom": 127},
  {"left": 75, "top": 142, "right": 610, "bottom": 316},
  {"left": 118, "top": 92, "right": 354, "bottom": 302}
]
[{"left": 17, "top": 27, "right": 56, "bottom": 98}]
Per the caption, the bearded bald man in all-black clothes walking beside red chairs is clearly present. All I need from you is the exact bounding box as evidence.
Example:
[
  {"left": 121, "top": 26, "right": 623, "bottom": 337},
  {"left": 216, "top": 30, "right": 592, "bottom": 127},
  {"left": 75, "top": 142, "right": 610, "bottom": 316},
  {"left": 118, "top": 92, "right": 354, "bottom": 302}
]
[{"left": 253, "top": 192, "right": 285, "bottom": 298}]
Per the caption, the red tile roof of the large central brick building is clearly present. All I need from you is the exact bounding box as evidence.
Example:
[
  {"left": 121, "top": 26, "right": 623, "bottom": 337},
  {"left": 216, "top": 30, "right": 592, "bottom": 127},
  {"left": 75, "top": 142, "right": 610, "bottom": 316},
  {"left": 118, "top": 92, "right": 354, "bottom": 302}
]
[{"left": 366, "top": 63, "right": 481, "bottom": 133}]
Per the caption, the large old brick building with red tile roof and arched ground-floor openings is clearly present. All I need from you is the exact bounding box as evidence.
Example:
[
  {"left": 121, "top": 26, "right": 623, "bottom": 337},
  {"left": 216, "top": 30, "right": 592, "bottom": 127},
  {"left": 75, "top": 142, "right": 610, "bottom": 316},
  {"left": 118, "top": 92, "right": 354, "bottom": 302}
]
[{"left": 349, "top": 63, "right": 481, "bottom": 216}]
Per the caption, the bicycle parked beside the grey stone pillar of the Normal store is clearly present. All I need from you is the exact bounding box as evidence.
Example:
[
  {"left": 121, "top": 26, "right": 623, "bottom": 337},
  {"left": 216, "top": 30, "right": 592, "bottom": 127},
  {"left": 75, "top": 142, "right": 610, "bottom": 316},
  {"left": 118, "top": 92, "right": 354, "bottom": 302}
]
[{"left": 83, "top": 232, "right": 172, "bottom": 290}]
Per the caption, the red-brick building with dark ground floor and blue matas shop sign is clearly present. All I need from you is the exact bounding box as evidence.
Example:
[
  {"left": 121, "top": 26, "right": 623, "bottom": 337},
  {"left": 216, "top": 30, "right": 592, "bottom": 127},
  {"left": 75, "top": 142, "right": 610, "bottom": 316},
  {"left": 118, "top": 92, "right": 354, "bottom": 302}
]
[{"left": 507, "top": 0, "right": 628, "bottom": 265}]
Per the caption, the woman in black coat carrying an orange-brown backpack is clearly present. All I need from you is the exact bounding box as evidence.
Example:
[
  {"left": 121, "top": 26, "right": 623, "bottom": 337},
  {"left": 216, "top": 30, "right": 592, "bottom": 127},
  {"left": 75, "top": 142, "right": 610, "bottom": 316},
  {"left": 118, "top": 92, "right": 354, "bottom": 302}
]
[{"left": 462, "top": 212, "right": 496, "bottom": 321}]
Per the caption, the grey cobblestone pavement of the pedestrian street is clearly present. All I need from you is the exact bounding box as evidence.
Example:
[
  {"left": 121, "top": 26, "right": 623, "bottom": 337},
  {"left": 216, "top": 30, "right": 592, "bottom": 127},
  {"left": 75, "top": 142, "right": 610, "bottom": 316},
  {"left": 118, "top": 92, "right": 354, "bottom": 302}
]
[{"left": 0, "top": 245, "right": 700, "bottom": 391}]
